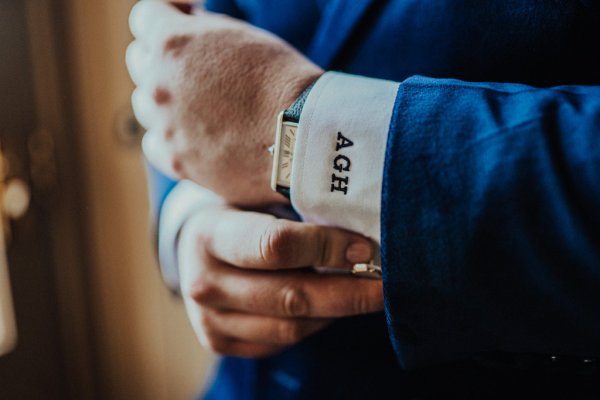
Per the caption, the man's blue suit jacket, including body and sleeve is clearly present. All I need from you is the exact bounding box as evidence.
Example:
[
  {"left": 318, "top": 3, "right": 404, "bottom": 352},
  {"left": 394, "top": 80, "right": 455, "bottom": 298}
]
[{"left": 152, "top": 0, "right": 600, "bottom": 399}]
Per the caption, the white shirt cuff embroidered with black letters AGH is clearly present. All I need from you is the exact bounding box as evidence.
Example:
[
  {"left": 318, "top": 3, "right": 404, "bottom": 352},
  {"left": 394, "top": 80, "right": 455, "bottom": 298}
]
[{"left": 291, "top": 72, "right": 399, "bottom": 244}]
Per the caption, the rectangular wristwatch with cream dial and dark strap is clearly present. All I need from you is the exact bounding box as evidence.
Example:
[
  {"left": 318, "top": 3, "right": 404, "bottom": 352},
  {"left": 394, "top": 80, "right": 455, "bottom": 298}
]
[{"left": 269, "top": 83, "right": 314, "bottom": 199}]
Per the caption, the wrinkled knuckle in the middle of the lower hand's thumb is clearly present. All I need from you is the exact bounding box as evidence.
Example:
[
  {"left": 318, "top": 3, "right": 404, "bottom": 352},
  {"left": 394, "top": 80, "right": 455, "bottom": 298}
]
[{"left": 259, "top": 220, "right": 294, "bottom": 266}]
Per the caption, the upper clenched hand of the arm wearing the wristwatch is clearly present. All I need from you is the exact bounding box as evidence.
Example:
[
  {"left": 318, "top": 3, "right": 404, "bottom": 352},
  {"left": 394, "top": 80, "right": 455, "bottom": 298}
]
[{"left": 127, "top": 0, "right": 323, "bottom": 206}]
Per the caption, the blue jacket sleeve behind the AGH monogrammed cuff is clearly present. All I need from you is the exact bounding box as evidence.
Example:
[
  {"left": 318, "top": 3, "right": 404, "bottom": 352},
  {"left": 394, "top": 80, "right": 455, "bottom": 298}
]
[{"left": 382, "top": 77, "right": 600, "bottom": 367}]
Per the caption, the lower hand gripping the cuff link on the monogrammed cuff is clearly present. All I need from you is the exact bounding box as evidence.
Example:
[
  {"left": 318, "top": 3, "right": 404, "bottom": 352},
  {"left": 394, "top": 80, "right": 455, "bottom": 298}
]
[{"left": 178, "top": 205, "right": 383, "bottom": 357}]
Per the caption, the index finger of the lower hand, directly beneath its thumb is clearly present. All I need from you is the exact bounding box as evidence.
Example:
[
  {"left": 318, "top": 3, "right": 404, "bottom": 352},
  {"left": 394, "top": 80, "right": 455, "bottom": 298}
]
[{"left": 186, "top": 267, "right": 383, "bottom": 318}]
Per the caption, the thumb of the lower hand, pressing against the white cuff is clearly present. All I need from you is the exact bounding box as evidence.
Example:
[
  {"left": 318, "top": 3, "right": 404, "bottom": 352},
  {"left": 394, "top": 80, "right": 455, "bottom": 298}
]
[{"left": 208, "top": 212, "right": 372, "bottom": 269}]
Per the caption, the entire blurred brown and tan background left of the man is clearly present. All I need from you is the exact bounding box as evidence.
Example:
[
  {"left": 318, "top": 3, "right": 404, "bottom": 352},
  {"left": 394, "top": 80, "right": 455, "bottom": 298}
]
[{"left": 0, "top": 0, "right": 212, "bottom": 399}]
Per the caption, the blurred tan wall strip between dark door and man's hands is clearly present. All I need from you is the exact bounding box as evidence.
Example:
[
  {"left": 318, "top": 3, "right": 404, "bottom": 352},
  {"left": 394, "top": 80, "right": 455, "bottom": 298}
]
[{"left": 63, "top": 0, "right": 211, "bottom": 399}]
